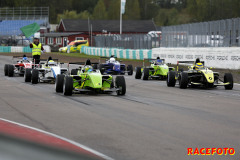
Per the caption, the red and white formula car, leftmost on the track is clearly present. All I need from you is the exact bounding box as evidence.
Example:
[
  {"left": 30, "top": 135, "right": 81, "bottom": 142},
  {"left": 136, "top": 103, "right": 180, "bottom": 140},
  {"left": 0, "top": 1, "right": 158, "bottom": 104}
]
[{"left": 4, "top": 56, "right": 35, "bottom": 77}]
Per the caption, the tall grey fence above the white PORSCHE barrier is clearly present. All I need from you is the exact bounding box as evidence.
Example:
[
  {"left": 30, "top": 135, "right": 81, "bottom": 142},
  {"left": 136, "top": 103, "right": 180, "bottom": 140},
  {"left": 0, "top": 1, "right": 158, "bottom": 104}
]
[{"left": 161, "top": 18, "right": 240, "bottom": 47}]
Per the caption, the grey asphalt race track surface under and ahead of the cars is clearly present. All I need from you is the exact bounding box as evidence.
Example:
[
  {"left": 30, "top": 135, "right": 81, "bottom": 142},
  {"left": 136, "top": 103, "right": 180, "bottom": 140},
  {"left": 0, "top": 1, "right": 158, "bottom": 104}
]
[{"left": 0, "top": 56, "right": 240, "bottom": 160}]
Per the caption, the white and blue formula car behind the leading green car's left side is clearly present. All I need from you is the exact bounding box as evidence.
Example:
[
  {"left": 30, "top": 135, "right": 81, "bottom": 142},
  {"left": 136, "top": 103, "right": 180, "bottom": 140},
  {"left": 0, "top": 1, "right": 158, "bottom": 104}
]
[{"left": 24, "top": 58, "right": 68, "bottom": 84}]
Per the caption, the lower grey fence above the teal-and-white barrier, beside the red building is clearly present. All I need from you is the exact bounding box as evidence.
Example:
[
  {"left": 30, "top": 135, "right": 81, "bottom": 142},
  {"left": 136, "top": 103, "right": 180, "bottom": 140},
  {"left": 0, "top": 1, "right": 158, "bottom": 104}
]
[{"left": 94, "top": 34, "right": 160, "bottom": 49}]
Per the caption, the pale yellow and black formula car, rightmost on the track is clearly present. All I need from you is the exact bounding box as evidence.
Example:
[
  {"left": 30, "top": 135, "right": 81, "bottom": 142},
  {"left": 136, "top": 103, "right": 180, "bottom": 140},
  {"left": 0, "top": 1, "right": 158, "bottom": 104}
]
[{"left": 167, "top": 61, "right": 233, "bottom": 90}]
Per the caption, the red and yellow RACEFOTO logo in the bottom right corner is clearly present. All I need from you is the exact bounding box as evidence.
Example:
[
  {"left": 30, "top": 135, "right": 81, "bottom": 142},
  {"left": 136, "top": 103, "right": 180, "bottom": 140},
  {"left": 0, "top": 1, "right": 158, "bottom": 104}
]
[{"left": 187, "top": 148, "right": 235, "bottom": 156}]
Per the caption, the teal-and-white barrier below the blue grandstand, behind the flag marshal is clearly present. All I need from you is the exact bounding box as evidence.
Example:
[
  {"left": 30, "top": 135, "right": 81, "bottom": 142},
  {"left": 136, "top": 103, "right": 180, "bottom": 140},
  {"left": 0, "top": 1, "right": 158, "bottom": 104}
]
[{"left": 0, "top": 45, "right": 51, "bottom": 53}]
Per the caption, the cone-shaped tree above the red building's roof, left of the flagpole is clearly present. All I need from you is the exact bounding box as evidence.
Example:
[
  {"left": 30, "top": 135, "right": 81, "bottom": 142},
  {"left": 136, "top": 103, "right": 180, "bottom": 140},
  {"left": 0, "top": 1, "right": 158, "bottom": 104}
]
[{"left": 93, "top": 0, "right": 107, "bottom": 19}]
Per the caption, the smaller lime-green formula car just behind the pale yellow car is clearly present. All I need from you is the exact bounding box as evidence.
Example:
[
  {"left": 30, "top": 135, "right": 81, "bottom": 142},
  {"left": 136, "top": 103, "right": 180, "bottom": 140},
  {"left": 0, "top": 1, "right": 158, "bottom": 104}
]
[{"left": 135, "top": 59, "right": 175, "bottom": 80}]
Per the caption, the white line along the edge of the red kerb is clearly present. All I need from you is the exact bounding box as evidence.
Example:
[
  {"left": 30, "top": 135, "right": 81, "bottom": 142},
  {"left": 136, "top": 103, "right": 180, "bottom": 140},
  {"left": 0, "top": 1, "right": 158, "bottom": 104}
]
[{"left": 0, "top": 118, "right": 114, "bottom": 160}]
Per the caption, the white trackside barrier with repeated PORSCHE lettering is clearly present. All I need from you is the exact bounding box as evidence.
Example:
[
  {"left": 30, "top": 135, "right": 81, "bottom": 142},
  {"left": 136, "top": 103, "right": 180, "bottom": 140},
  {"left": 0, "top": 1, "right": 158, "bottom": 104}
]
[{"left": 152, "top": 47, "right": 240, "bottom": 69}]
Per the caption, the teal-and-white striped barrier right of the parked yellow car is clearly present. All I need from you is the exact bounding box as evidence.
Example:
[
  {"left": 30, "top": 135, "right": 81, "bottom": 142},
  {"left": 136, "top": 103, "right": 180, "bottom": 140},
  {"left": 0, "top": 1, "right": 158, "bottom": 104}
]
[{"left": 81, "top": 47, "right": 152, "bottom": 60}]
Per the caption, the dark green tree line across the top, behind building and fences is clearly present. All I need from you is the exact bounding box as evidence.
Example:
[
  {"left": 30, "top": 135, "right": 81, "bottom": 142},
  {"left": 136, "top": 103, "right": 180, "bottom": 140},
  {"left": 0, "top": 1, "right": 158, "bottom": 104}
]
[{"left": 0, "top": 0, "right": 240, "bottom": 26}]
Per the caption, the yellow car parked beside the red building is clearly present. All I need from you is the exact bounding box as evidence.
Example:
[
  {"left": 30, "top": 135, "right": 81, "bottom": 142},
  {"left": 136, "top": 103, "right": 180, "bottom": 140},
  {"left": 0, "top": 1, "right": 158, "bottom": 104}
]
[{"left": 59, "top": 40, "right": 89, "bottom": 53}]
